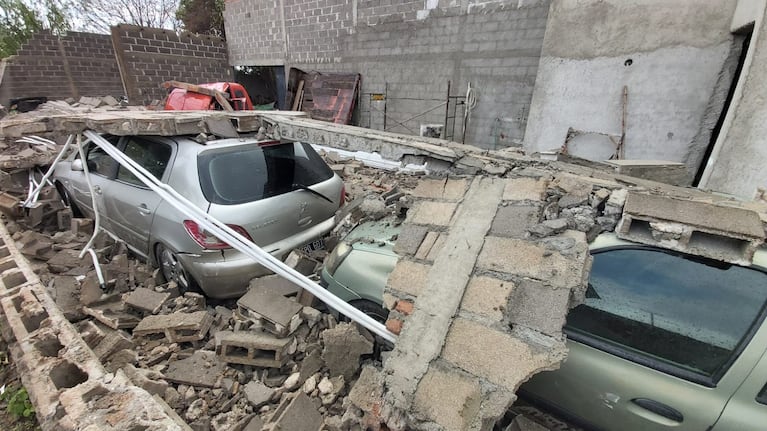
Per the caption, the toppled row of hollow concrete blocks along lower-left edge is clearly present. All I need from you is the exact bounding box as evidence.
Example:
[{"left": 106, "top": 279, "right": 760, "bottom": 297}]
[{"left": 0, "top": 221, "right": 184, "bottom": 431}]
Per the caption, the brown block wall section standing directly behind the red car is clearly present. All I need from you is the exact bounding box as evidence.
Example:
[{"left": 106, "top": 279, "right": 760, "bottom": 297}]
[{"left": 112, "top": 24, "right": 232, "bottom": 104}]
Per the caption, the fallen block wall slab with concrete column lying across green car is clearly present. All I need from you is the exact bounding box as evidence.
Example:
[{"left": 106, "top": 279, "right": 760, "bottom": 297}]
[{"left": 382, "top": 177, "right": 591, "bottom": 430}]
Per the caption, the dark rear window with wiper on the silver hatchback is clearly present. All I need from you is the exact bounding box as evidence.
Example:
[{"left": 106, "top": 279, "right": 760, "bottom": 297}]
[{"left": 197, "top": 142, "right": 333, "bottom": 205}]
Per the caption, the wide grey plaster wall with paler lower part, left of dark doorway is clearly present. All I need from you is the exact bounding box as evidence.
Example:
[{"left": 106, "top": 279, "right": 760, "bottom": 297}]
[{"left": 525, "top": 0, "right": 737, "bottom": 174}]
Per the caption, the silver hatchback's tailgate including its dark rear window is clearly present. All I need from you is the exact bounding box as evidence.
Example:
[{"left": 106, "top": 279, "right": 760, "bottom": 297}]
[{"left": 198, "top": 142, "right": 341, "bottom": 251}]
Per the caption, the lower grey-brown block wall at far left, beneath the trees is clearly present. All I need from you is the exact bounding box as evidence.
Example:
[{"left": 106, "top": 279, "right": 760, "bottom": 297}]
[{"left": 0, "top": 31, "right": 124, "bottom": 106}]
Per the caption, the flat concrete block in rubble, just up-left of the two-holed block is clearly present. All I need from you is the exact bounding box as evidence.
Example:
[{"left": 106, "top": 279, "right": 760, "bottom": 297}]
[{"left": 133, "top": 311, "right": 213, "bottom": 343}]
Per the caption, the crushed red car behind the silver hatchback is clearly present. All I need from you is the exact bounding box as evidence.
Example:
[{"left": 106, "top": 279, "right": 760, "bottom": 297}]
[{"left": 165, "top": 82, "right": 253, "bottom": 111}]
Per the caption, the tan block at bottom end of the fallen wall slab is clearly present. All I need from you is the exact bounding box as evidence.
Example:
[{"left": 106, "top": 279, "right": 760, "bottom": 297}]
[{"left": 413, "top": 365, "right": 482, "bottom": 431}]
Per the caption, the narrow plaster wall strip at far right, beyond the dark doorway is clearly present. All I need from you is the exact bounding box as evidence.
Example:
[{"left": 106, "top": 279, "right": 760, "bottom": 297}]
[{"left": 701, "top": 0, "right": 767, "bottom": 199}]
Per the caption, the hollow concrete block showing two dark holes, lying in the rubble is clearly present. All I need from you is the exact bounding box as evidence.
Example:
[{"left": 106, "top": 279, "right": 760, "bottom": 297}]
[{"left": 216, "top": 330, "right": 293, "bottom": 368}]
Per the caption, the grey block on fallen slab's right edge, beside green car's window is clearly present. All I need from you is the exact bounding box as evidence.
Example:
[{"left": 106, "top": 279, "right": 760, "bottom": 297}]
[{"left": 506, "top": 280, "right": 570, "bottom": 337}]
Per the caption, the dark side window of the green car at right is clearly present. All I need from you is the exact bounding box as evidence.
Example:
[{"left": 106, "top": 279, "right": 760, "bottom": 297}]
[{"left": 566, "top": 247, "right": 767, "bottom": 386}]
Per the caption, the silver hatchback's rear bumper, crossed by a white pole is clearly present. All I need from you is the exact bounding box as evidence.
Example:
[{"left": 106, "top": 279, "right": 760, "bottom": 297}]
[{"left": 178, "top": 218, "right": 335, "bottom": 298}]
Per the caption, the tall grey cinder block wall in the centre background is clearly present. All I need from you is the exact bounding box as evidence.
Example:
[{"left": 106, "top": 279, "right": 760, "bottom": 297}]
[{"left": 224, "top": 0, "right": 549, "bottom": 148}]
